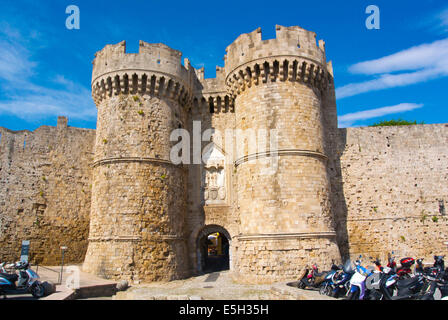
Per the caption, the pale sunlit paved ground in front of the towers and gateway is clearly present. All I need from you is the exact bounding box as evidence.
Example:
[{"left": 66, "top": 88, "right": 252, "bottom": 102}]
[{"left": 13, "top": 266, "right": 440, "bottom": 300}]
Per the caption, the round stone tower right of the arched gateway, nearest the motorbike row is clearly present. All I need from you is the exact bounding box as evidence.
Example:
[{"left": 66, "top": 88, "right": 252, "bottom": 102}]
[{"left": 225, "top": 26, "right": 340, "bottom": 282}]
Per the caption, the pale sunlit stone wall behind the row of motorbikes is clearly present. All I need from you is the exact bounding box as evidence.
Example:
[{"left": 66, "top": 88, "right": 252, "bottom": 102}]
[{"left": 333, "top": 124, "right": 448, "bottom": 263}]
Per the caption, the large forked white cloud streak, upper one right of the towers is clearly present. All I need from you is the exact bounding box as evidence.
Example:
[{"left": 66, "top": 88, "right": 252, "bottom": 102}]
[{"left": 336, "top": 38, "right": 448, "bottom": 99}]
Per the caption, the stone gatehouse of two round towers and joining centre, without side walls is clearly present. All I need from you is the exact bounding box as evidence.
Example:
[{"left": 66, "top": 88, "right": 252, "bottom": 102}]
[{"left": 84, "top": 26, "right": 340, "bottom": 282}]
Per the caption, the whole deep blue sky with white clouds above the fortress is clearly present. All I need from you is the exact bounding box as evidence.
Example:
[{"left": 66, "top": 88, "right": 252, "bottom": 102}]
[{"left": 0, "top": 0, "right": 448, "bottom": 130}]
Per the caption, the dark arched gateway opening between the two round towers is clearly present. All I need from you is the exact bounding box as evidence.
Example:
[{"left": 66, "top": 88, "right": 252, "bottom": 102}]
[{"left": 197, "top": 225, "right": 231, "bottom": 273}]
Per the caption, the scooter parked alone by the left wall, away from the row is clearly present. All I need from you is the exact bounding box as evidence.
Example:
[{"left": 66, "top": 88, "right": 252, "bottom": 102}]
[{"left": 0, "top": 262, "right": 45, "bottom": 299}]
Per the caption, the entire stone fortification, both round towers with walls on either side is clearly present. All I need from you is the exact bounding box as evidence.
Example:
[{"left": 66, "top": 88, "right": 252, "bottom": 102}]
[{"left": 0, "top": 26, "right": 448, "bottom": 284}]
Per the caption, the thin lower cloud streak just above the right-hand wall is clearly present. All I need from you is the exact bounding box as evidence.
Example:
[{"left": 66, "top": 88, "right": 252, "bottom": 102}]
[{"left": 338, "top": 103, "right": 423, "bottom": 128}]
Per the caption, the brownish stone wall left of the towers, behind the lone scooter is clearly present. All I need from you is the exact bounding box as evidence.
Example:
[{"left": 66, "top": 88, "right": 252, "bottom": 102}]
[{"left": 0, "top": 117, "right": 95, "bottom": 265}]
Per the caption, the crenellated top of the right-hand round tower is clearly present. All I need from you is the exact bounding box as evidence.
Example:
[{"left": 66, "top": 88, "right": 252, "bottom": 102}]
[{"left": 224, "top": 25, "right": 332, "bottom": 96}]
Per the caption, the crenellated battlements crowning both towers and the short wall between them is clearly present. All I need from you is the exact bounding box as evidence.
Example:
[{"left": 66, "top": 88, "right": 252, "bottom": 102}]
[{"left": 92, "top": 25, "right": 333, "bottom": 109}]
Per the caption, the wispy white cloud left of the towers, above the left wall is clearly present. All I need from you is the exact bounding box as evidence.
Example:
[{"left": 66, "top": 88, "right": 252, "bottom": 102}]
[{"left": 0, "top": 27, "right": 96, "bottom": 121}]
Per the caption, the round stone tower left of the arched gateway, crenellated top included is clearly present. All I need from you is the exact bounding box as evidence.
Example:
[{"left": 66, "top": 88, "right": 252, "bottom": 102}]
[{"left": 83, "top": 41, "right": 194, "bottom": 281}]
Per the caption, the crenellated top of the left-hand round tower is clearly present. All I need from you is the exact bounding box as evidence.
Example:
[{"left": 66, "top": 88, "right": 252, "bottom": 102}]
[{"left": 92, "top": 41, "right": 197, "bottom": 104}]
